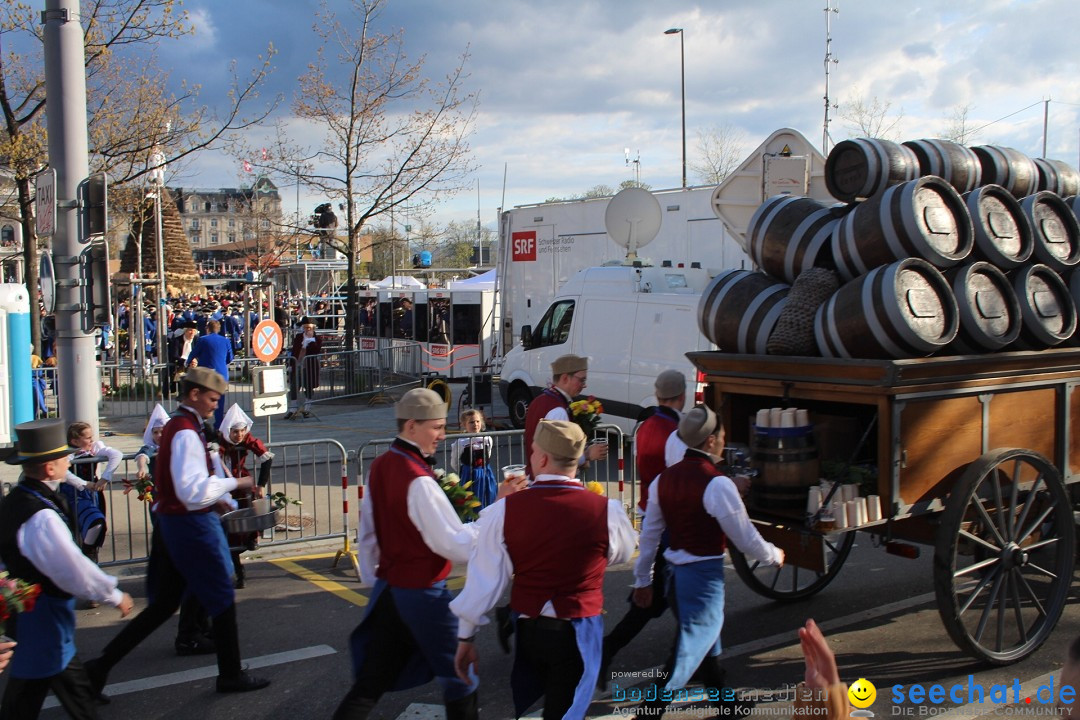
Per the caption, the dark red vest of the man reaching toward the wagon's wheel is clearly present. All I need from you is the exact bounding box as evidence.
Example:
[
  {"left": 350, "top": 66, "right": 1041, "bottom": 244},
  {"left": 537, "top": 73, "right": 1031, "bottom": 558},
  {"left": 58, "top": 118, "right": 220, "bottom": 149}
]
[{"left": 657, "top": 452, "right": 727, "bottom": 556}]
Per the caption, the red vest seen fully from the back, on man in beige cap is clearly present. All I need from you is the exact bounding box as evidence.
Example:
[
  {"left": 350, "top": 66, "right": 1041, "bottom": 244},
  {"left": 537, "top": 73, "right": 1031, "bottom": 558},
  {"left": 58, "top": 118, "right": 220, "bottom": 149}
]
[{"left": 502, "top": 480, "right": 609, "bottom": 617}]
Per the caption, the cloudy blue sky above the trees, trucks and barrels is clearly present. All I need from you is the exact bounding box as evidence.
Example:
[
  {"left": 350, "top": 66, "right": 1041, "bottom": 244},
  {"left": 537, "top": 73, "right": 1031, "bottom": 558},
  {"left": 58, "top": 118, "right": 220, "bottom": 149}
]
[{"left": 147, "top": 0, "right": 1080, "bottom": 226}]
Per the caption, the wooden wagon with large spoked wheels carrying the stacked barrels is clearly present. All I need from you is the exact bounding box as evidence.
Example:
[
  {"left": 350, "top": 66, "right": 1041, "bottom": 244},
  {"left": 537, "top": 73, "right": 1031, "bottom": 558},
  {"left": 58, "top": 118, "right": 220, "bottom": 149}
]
[{"left": 688, "top": 349, "right": 1080, "bottom": 664}]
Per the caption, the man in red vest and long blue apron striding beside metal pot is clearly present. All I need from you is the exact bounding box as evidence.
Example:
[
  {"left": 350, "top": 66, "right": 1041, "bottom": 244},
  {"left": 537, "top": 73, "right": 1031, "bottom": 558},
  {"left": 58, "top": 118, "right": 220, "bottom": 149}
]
[{"left": 150, "top": 369, "right": 270, "bottom": 693}]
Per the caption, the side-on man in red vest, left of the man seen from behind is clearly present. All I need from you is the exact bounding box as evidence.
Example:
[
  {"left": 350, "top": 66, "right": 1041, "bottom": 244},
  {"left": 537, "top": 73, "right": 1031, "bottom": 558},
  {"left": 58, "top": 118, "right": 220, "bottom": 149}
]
[{"left": 334, "top": 388, "right": 524, "bottom": 720}]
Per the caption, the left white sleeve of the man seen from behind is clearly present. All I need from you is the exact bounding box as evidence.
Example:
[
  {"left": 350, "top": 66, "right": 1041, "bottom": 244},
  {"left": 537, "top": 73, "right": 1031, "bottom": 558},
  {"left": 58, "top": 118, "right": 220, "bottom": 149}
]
[{"left": 450, "top": 500, "right": 514, "bottom": 638}]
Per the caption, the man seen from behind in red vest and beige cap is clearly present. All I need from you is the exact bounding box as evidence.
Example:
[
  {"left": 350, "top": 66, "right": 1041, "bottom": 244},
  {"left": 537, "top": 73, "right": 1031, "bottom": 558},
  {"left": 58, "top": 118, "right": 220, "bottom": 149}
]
[{"left": 450, "top": 420, "right": 636, "bottom": 720}]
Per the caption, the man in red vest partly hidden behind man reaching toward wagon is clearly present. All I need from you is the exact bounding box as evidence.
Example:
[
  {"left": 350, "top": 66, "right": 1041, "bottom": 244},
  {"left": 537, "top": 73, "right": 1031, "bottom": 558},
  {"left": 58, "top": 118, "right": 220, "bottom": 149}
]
[{"left": 599, "top": 370, "right": 686, "bottom": 688}]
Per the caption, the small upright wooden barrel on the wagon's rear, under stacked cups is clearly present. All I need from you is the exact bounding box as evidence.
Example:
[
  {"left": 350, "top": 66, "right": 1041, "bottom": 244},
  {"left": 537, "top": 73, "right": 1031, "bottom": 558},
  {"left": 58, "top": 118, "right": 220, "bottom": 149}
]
[{"left": 751, "top": 425, "right": 821, "bottom": 511}]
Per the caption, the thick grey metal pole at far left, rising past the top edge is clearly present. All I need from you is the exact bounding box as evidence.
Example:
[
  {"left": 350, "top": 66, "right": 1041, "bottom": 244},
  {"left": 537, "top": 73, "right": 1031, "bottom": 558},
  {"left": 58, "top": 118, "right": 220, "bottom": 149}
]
[{"left": 43, "top": 0, "right": 102, "bottom": 434}]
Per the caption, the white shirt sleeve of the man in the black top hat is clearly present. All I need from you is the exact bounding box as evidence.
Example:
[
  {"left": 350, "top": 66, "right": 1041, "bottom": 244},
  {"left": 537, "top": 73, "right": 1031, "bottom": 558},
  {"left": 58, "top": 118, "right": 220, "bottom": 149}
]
[{"left": 15, "top": 510, "right": 123, "bottom": 606}]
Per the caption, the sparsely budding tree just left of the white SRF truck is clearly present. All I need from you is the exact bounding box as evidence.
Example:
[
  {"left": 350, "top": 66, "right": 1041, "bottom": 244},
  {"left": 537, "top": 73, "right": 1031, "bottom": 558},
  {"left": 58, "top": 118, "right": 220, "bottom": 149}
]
[{"left": 252, "top": 0, "right": 477, "bottom": 349}]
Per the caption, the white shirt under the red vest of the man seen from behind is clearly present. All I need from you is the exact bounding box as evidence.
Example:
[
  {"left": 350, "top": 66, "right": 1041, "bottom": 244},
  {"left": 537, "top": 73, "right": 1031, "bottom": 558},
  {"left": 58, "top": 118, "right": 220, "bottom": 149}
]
[{"left": 450, "top": 475, "right": 637, "bottom": 638}]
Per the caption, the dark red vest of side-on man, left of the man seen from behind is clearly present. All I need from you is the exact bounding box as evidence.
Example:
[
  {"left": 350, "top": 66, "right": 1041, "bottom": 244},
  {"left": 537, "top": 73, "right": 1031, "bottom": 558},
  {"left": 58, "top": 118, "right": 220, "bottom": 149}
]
[{"left": 367, "top": 440, "right": 450, "bottom": 589}]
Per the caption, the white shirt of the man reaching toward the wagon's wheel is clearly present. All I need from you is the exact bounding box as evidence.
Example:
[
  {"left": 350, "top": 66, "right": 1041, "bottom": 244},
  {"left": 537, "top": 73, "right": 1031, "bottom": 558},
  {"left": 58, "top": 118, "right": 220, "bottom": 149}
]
[{"left": 634, "top": 462, "right": 781, "bottom": 587}]
